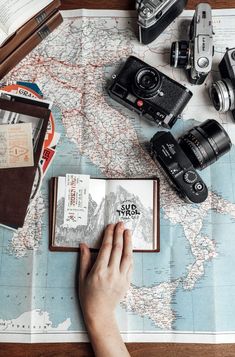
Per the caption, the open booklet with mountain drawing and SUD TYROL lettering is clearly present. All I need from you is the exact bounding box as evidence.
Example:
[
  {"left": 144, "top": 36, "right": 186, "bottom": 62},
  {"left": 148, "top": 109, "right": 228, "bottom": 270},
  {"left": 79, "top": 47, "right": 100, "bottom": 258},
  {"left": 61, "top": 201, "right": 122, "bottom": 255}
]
[{"left": 49, "top": 174, "right": 160, "bottom": 252}]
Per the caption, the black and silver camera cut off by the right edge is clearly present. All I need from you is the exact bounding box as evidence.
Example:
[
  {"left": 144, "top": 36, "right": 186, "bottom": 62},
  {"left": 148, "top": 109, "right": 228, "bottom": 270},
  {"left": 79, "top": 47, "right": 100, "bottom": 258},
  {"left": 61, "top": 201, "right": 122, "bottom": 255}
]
[{"left": 210, "top": 48, "right": 235, "bottom": 119}]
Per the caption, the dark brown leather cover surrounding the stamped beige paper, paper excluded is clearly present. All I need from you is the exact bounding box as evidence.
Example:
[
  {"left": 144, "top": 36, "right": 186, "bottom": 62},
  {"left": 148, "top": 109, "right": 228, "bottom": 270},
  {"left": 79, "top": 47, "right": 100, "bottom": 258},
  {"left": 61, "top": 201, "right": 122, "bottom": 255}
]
[{"left": 0, "top": 99, "right": 51, "bottom": 228}]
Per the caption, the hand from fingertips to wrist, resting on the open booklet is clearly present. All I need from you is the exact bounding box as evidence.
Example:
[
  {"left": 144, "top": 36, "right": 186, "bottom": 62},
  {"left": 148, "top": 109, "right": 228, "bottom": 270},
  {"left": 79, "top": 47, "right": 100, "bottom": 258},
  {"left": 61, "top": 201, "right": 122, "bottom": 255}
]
[{"left": 79, "top": 222, "right": 132, "bottom": 330}]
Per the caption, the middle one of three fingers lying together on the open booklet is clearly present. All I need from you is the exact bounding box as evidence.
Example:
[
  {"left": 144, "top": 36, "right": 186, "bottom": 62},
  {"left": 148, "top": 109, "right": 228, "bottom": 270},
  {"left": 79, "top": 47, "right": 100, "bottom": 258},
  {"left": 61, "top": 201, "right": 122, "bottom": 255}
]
[{"left": 109, "top": 222, "right": 125, "bottom": 269}]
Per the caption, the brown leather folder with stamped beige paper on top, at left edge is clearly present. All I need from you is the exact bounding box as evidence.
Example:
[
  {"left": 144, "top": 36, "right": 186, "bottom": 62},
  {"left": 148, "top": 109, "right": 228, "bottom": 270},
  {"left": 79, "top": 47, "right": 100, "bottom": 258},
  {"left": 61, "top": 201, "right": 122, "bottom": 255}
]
[{"left": 0, "top": 87, "right": 51, "bottom": 230}]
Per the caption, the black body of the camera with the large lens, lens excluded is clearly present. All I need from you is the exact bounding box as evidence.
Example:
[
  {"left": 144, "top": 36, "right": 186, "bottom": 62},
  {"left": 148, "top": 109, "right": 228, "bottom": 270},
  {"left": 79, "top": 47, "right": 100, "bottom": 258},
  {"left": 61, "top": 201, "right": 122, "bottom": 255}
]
[{"left": 151, "top": 131, "right": 208, "bottom": 203}]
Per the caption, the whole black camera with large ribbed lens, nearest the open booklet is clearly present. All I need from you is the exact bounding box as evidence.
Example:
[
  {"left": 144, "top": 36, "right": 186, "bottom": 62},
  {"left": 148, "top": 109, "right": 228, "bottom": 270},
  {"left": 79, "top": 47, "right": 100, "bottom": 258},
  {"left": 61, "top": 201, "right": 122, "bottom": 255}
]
[{"left": 151, "top": 119, "right": 232, "bottom": 203}]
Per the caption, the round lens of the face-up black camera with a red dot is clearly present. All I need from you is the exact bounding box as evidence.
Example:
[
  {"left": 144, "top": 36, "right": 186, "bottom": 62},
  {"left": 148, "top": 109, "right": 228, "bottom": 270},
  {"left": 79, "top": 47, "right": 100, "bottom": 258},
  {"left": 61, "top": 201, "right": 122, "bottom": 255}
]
[{"left": 133, "top": 67, "right": 161, "bottom": 98}]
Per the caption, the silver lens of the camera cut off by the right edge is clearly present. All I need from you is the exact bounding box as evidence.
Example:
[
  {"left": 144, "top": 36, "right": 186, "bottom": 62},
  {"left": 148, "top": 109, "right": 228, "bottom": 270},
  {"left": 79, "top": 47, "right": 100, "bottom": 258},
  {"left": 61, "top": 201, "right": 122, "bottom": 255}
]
[{"left": 210, "top": 79, "right": 235, "bottom": 113}]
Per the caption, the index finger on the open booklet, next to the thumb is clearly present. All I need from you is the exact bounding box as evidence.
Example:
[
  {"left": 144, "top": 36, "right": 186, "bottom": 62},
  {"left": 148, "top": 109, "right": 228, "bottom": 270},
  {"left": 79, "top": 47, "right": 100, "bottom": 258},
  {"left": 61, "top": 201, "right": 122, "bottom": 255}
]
[{"left": 94, "top": 224, "right": 115, "bottom": 267}]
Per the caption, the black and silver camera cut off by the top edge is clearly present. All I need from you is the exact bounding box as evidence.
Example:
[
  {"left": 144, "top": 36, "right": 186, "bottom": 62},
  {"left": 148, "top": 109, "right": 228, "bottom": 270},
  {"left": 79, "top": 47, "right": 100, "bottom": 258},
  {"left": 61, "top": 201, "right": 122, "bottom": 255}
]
[{"left": 136, "top": 0, "right": 187, "bottom": 44}]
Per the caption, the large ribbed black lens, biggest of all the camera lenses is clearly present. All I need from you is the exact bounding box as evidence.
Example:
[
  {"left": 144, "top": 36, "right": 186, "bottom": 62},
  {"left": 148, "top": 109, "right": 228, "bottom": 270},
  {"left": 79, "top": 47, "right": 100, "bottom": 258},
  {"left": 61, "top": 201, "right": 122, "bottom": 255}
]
[{"left": 179, "top": 119, "right": 232, "bottom": 170}]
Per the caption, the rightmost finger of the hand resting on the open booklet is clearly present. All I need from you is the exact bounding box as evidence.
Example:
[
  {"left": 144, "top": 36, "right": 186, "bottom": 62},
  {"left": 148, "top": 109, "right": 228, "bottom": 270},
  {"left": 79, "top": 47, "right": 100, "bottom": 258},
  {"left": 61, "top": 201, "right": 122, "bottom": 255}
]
[{"left": 120, "top": 229, "right": 133, "bottom": 275}]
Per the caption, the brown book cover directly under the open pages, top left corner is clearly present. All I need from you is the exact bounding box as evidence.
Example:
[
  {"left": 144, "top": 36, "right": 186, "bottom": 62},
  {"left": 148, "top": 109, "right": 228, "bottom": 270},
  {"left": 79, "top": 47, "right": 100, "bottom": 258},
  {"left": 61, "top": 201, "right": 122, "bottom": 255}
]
[{"left": 0, "top": 0, "right": 61, "bottom": 64}]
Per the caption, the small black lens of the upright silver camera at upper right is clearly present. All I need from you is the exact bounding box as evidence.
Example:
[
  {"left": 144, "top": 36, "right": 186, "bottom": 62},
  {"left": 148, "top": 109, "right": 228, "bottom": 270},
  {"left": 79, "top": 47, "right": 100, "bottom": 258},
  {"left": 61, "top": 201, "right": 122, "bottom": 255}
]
[{"left": 171, "top": 41, "right": 189, "bottom": 68}]
